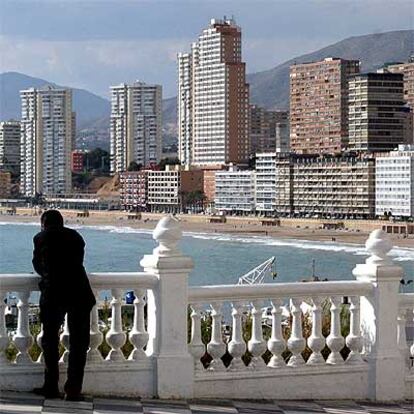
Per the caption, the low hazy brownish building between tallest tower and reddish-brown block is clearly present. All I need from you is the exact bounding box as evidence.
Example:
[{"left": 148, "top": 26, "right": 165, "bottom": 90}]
[{"left": 250, "top": 105, "right": 290, "bottom": 154}]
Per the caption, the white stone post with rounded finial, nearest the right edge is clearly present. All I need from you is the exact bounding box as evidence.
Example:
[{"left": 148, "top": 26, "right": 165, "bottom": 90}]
[{"left": 353, "top": 230, "right": 405, "bottom": 401}]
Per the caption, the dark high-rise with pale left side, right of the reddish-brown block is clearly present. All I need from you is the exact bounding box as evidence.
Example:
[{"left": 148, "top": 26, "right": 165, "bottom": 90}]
[{"left": 348, "top": 73, "right": 409, "bottom": 152}]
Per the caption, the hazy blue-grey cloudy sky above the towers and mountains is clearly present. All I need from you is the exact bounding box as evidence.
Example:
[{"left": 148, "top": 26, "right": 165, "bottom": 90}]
[{"left": 0, "top": 0, "right": 414, "bottom": 97}]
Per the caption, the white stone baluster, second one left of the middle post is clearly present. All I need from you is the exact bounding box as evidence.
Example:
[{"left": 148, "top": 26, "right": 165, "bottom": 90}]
[{"left": 106, "top": 289, "right": 126, "bottom": 361}]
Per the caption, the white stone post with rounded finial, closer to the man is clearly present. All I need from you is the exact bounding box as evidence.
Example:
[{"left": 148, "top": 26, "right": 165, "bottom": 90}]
[{"left": 141, "top": 216, "right": 194, "bottom": 398}]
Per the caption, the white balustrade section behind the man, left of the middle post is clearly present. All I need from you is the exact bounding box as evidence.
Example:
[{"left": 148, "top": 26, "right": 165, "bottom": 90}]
[{"left": 0, "top": 272, "right": 158, "bottom": 366}]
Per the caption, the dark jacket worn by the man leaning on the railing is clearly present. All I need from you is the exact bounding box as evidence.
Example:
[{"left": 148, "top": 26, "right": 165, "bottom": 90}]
[{"left": 32, "top": 227, "right": 96, "bottom": 309}]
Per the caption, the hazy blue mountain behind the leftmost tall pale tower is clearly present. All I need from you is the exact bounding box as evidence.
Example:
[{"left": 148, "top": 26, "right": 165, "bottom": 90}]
[{"left": 0, "top": 72, "right": 111, "bottom": 128}]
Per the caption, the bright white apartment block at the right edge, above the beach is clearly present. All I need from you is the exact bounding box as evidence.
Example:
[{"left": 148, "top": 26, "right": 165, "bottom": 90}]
[{"left": 375, "top": 145, "right": 414, "bottom": 217}]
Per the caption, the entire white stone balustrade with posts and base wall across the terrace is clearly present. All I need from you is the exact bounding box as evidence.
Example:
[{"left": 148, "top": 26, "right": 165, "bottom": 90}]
[{"left": 0, "top": 217, "right": 414, "bottom": 402}]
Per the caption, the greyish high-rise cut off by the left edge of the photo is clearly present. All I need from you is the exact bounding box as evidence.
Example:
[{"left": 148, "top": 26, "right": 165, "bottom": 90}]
[{"left": 0, "top": 121, "right": 20, "bottom": 175}]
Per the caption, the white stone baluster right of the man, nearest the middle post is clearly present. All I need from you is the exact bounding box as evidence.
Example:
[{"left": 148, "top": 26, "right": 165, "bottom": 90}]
[{"left": 128, "top": 289, "right": 148, "bottom": 361}]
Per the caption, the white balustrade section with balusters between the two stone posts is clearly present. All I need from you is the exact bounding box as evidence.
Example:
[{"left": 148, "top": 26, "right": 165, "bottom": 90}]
[{"left": 189, "top": 281, "right": 373, "bottom": 372}]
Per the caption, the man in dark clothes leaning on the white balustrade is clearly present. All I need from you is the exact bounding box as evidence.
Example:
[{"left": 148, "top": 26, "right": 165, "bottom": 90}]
[{"left": 33, "top": 210, "right": 96, "bottom": 401}]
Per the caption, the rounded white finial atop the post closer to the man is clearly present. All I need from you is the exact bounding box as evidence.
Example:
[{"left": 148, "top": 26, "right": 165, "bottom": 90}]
[{"left": 152, "top": 215, "right": 182, "bottom": 256}]
